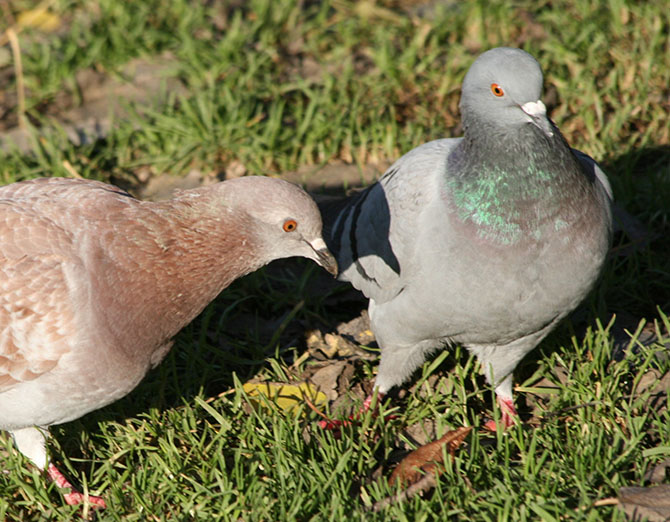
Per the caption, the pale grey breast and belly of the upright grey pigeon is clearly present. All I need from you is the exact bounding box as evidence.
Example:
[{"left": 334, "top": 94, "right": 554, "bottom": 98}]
[{"left": 371, "top": 173, "right": 611, "bottom": 345}]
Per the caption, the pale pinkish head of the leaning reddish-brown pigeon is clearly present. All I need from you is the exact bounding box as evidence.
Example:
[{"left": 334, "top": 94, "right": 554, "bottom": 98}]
[{"left": 221, "top": 176, "right": 337, "bottom": 275}]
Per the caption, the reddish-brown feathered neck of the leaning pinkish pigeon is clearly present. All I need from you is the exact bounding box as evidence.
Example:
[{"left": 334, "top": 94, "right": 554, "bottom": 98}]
[{"left": 88, "top": 201, "right": 265, "bottom": 354}]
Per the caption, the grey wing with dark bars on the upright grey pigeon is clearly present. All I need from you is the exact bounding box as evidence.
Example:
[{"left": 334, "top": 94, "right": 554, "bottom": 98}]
[{"left": 326, "top": 140, "right": 458, "bottom": 303}]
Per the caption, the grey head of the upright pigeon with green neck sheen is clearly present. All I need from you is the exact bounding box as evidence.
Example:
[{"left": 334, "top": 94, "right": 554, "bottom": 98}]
[{"left": 460, "top": 47, "right": 554, "bottom": 137}]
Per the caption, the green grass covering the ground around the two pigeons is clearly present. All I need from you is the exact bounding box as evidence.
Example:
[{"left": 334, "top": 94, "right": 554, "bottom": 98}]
[{"left": 0, "top": 0, "right": 670, "bottom": 520}]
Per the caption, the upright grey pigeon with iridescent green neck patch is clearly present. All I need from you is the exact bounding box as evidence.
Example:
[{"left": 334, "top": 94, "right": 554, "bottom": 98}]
[{"left": 322, "top": 47, "right": 612, "bottom": 428}]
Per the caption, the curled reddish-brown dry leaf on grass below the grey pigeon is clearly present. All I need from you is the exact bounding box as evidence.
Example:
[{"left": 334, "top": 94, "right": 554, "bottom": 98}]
[{"left": 389, "top": 426, "right": 472, "bottom": 485}]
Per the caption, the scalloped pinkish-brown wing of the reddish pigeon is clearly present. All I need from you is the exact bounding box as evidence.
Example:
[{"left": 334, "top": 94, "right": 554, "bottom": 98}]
[{"left": 0, "top": 200, "right": 80, "bottom": 393}]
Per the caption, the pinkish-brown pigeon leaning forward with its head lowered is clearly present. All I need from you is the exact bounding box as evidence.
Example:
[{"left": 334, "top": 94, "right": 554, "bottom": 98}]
[{"left": 0, "top": 177, "right": 337, "bottom": 506}]
